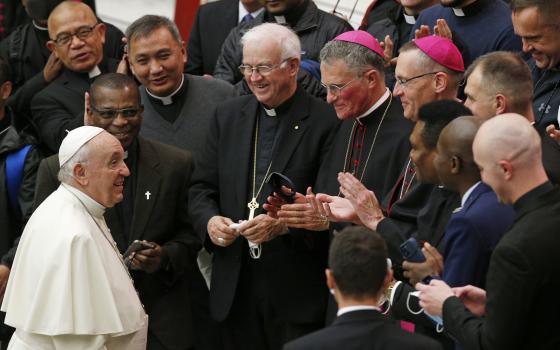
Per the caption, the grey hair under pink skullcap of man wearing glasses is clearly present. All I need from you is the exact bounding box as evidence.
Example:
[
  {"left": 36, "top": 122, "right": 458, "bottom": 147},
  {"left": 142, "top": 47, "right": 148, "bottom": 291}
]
[{"left": 320, "top": 40, "right": 385, "bottom": 76}]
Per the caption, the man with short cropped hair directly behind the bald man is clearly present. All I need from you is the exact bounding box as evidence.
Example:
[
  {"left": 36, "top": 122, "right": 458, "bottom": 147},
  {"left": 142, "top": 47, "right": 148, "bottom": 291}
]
[{"left": 465, "top": 51, "right": 560, "bottom": 184}]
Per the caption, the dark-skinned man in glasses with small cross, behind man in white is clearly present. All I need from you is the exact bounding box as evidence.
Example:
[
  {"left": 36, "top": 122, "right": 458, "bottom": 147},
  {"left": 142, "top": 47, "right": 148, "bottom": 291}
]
[{"left": 31, "top": 73, "right": 200, "bottom": 349}]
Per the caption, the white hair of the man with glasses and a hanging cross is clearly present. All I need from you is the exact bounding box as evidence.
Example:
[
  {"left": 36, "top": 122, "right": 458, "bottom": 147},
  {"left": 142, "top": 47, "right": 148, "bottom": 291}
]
[{"left": 241, "top": 23, "right": 301, "bottom": 60}]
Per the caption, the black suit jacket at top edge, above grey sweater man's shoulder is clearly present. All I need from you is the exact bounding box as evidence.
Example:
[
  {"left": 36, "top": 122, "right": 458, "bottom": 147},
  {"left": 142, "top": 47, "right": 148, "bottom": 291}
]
[{"left": 185, "top": 0, "right": 239, "bottom": 75}]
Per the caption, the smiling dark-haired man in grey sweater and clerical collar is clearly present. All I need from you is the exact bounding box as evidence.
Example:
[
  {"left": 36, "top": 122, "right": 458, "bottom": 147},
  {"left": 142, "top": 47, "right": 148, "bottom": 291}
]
[{"left": 126, "top": 15, "right": 235, "bottom": 155}]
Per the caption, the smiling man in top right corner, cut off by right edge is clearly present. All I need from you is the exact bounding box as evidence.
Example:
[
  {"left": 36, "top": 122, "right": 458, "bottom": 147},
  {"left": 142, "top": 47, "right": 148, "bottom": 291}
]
[{"left": 510, "top": 0, "right": 560, "bottom": 131}]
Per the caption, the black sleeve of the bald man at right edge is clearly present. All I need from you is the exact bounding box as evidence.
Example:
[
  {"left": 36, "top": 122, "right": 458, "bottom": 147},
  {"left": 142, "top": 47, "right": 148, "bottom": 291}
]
[{"left": 443, "top": 245, "right": 538, "bottom": 350}]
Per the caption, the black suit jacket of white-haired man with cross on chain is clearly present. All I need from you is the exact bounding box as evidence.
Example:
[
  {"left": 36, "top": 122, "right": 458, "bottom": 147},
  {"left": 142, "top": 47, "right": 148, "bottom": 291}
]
[{"left": 189, "top": 88, "right": 338, "bottom": 323}]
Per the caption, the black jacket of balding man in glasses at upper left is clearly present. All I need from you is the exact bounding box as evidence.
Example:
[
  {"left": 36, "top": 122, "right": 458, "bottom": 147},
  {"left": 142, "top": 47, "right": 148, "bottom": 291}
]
[{"left": 31, "top": 58, "right": 119, "bottom": 154}]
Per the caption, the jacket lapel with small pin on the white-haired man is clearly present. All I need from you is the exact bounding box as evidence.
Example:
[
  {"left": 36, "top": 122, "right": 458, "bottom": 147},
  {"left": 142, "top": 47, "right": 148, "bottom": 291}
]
[{"left": 271, "top": 87, "right": 309, "bottom": 172}]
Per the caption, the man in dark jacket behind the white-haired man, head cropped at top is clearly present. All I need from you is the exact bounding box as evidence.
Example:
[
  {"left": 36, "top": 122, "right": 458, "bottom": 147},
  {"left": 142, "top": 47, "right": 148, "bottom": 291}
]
[{"left": 214, "top": 0, "right": 352, "bottom": 95}]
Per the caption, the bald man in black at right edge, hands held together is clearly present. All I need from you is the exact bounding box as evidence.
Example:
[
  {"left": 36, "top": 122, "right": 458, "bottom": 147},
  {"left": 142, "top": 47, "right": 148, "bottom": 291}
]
[{"left": 416, "top": 114, "right": 560, "bottom": 349}]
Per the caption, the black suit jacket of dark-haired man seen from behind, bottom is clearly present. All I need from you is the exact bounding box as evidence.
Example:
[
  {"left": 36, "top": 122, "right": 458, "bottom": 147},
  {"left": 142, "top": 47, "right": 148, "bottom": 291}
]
[{"left": 284, "top": 310, "right": 442, "bottom": 350}]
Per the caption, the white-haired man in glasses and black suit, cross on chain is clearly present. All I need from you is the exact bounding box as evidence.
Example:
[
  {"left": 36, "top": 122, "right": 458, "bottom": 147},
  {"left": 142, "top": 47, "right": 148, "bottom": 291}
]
[{"left": 189, "top": 23, "right": 338, "bottom": 350}]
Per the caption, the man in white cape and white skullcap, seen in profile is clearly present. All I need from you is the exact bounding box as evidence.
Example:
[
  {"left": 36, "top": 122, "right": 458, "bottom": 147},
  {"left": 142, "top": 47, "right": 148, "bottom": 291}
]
[{"left": 2, "top": 126, "right": 148, "bottom": 350}]
